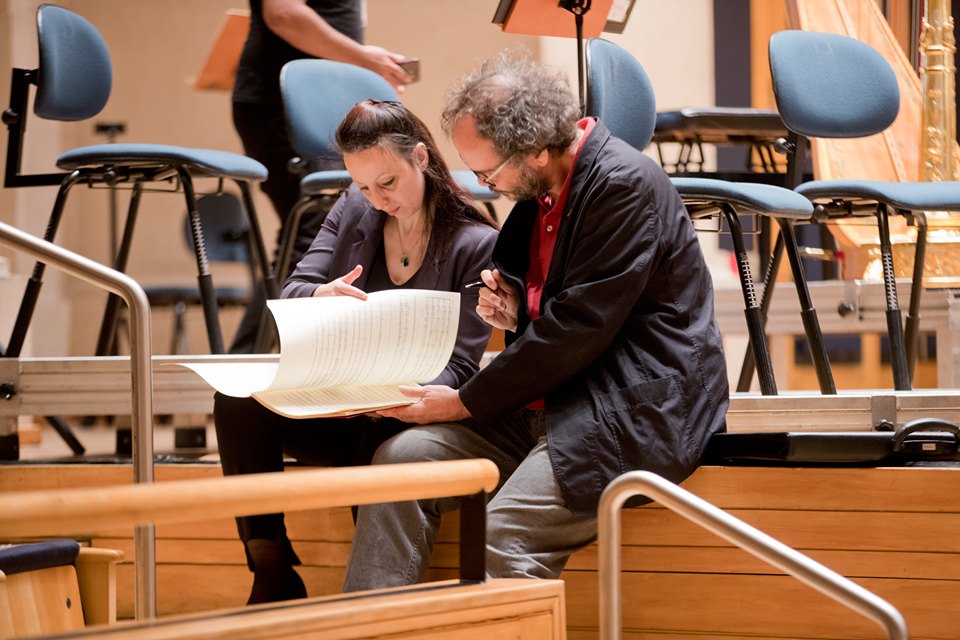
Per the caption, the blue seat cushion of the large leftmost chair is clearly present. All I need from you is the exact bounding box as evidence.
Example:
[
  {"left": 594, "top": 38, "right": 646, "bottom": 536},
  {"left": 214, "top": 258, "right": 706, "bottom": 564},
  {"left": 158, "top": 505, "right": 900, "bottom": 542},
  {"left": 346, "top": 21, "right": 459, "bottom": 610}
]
[{"left": 57, "top": 144, "right": 267, "bottom": 182}]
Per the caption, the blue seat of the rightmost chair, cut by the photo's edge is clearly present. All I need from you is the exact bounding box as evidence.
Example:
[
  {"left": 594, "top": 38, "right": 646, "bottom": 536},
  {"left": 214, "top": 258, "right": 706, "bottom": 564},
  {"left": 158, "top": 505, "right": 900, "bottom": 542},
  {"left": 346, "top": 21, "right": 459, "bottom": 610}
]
[{"left": 796, "top": 180, "right": 960, "bottom": 215}]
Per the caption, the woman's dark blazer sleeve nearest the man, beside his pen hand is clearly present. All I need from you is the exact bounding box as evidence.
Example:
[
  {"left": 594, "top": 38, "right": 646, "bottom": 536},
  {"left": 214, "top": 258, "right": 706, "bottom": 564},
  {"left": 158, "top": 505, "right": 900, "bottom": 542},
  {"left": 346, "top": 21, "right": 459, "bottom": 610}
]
[{"left": 430, "top": 224, "right": 497, "bottom": 389}]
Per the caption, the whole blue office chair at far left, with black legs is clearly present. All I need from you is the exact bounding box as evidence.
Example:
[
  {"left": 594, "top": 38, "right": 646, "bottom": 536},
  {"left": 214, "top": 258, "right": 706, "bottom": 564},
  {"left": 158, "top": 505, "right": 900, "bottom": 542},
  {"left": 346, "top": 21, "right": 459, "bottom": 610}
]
[{"left": 3, "top": 4, "right": 278, "bottom": 356}]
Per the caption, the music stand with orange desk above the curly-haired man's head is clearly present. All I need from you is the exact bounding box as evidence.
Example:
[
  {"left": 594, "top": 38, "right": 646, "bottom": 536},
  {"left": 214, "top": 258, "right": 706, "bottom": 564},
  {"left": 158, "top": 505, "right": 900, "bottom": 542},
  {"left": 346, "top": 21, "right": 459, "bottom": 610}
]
[{"left": 493, "top": 0, "right": 635, "bottom": 113}]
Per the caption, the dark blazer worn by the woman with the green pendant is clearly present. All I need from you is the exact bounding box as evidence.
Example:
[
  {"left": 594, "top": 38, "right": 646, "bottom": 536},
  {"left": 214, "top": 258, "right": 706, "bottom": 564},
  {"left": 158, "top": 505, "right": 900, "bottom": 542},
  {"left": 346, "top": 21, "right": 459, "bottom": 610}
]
[{"left": 281, "top": 185, "right": 497, "bottom": 388}]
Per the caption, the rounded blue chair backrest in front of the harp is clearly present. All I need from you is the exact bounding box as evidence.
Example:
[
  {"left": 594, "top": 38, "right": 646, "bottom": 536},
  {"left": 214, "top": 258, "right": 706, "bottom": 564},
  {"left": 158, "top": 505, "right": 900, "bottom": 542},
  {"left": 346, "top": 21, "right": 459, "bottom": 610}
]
[{"left": 769, "top": 31, "right": 900, "bottom": 138}]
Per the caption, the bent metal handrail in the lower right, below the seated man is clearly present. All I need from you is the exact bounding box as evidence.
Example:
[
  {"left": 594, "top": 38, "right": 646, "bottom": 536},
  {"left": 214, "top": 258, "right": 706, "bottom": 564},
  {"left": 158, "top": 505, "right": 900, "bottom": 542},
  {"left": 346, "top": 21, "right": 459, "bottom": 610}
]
[{"left": 598, "top": 471, "right": 910, "bottom": 640}]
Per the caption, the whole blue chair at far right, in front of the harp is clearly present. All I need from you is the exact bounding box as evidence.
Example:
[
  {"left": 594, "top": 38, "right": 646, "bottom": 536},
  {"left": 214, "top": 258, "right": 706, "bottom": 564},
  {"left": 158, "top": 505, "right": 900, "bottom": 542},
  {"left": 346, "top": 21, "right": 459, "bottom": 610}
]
[{"left": 769, "top": 31, "right": 960, "bottom": 390}]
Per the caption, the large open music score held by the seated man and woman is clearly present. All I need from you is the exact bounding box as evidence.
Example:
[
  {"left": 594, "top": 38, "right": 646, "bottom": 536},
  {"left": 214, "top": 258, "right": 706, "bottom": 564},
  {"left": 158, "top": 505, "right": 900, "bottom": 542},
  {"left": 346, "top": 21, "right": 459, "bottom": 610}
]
[{"left": 182, "top": 289, "right": 460, "bottom": 418}]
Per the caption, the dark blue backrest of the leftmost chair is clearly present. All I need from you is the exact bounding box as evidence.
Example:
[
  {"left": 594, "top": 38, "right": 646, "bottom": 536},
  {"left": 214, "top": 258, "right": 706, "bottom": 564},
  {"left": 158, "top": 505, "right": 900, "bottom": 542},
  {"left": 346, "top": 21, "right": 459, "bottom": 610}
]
[{"left": 33, "top": 4, "right": 113, "bottom": 121}]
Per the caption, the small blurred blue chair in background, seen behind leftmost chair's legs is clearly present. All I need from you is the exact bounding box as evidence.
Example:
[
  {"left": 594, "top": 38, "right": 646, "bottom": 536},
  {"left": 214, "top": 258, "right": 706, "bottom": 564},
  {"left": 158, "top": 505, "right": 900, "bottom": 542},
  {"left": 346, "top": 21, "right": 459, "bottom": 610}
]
[{"left": 144, "top": 192, "right": 256, "bottom": 354}]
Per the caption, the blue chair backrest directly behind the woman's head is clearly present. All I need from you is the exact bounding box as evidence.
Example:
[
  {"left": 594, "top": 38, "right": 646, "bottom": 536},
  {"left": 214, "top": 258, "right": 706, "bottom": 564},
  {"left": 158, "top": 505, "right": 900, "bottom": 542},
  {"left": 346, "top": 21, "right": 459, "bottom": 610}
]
[{"left": 280, "top": 60, "right": 400, "bottom": 161}]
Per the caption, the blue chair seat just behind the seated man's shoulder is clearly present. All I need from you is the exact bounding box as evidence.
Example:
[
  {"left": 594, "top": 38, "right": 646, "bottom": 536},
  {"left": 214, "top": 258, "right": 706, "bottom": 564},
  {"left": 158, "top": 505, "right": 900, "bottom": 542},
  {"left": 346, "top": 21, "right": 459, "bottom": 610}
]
[{"left": 670, "top": 178, "right": 813, "bottom": 220}]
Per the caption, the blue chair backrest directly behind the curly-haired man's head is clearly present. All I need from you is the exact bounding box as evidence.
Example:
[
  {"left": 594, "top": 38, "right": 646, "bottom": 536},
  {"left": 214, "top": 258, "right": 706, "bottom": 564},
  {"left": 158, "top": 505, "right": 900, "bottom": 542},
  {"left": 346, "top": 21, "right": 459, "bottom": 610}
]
[{"left": 584, "top": 38, "right": 657, "bottom": 151}]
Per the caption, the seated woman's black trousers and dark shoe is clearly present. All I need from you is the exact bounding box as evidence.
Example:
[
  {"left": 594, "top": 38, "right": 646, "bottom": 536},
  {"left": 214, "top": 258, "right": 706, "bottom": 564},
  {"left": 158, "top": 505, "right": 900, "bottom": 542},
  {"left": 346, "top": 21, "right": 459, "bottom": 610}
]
[{"left": 213, "top": 393, "right": 409, "bottom": 604}]
